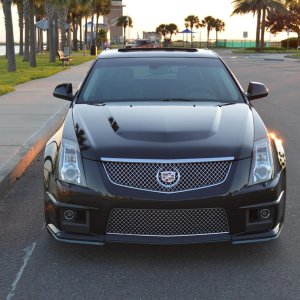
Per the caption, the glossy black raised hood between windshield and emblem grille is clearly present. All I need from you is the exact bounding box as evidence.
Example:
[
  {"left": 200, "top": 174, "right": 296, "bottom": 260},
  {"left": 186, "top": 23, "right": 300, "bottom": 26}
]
[{"left": 73, "top": 103, "right": 254, "bottom": 160}]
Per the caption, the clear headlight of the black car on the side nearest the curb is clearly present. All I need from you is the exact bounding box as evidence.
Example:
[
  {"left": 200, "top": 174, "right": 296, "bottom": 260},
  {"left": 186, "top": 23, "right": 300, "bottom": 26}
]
[{"left": 58, "top": 139, "right": 86, "bottom": 186}]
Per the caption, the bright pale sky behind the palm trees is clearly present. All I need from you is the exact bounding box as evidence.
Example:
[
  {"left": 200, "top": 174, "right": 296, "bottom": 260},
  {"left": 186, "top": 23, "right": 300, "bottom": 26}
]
[{"left": 0, "top": 0, "right": 296, "bottom": 42}]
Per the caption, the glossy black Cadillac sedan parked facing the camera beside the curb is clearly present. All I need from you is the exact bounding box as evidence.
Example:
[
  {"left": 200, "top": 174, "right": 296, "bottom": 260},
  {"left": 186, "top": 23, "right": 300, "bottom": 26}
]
[{"left": 44, "top": 48, "right": 286, "bottom": 245}]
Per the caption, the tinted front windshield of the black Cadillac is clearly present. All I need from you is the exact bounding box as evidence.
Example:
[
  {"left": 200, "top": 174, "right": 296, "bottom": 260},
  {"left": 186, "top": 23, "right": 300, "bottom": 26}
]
[{"left": 77, "top": 57, "right": 243, "bottom": 103}]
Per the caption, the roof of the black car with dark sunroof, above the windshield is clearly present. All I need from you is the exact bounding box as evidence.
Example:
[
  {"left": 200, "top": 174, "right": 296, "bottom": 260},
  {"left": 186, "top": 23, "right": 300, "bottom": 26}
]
[{"left": 98, "top": 48, "right": 220, "bottom": 58}]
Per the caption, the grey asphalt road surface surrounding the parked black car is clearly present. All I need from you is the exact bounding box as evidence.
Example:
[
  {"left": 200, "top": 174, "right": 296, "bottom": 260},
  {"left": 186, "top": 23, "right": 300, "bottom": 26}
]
[{"left": 0, "top": 55, "right": 300, "bottom": 300}]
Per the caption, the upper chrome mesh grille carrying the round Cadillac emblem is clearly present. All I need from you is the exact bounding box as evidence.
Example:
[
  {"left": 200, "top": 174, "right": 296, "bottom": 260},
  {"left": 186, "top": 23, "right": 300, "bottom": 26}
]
[{"left": 103, "top": 159, "right": 231, "bottom": 193}]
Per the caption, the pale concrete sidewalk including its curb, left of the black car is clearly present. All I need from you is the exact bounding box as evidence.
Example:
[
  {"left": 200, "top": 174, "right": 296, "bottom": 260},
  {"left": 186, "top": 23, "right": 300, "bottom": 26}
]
[{"left": 0, "top": 62, "right": 91, "bottom": 199}]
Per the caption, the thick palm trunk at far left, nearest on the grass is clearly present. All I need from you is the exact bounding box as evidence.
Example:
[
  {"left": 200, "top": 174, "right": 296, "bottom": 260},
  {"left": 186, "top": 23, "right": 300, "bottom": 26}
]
[{"left": 3, "top": 0, "right": 17, "bottom": 72}]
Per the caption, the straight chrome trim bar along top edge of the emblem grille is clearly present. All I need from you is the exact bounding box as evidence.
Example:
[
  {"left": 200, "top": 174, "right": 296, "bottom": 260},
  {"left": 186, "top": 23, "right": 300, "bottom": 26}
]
[{"left": 100, "top": 156, "right": 234, "bottom": 164}]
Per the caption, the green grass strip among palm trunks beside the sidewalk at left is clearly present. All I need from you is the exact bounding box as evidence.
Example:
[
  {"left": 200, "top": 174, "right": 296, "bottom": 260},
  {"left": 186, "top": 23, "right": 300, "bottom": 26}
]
[{"left": 0, "top": 52, "right": 95, "bottom": 95}]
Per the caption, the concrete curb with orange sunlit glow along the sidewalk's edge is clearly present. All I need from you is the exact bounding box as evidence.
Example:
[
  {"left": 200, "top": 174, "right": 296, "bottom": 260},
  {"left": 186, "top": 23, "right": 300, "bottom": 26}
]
[{"left": 0, "top": 104, "right": 69, "bottom": 199}]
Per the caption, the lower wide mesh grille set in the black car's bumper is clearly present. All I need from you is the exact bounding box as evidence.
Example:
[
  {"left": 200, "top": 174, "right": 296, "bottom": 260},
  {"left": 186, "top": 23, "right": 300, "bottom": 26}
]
[{"left": 106, "top": 208, "right": 229, "bottom": 236}]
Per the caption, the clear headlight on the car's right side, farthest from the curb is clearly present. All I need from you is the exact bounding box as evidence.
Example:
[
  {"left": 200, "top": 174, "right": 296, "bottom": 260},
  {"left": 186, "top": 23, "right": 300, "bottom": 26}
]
[{"left": 249, "top": 138, "right": 274, "bottom": 185}]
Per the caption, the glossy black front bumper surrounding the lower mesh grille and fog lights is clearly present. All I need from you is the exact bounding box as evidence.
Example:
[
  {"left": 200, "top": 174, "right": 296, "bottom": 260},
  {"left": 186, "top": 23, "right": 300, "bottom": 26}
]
[{"left": 45, "top": 168, "right": 286, "bottom": 245}]
